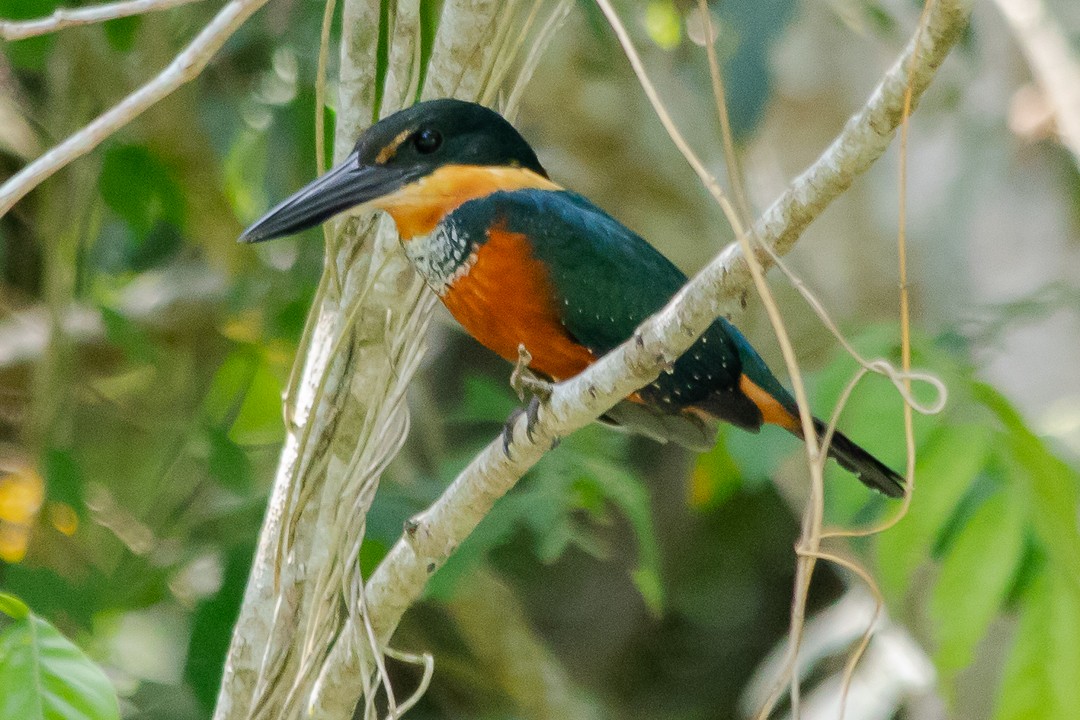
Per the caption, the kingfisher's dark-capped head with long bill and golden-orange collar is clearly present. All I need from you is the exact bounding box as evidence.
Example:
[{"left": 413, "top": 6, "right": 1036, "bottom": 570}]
[{"left": 240, "top": 99, "right": 556, "bottom": 243}]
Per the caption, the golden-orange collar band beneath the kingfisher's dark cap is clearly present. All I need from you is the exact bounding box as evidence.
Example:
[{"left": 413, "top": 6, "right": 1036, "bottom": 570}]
[{"left": 373, "top": 165, "right": 562, "bottom": 239}]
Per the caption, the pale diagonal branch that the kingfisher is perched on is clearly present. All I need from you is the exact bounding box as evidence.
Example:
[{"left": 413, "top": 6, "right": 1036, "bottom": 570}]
[{"left": 336, "top": 0, "right": 972, "bottom": 690}]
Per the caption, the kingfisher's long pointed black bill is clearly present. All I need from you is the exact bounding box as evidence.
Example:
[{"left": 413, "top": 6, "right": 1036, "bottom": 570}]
[{"left": 240, "top": 152, "right": 406, "bottom": 243}]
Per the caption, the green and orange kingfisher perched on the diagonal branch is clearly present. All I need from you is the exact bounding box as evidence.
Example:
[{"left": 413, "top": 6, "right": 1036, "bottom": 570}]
[{"left": 241, "top": 99, "right": 903, "bottom": 498}]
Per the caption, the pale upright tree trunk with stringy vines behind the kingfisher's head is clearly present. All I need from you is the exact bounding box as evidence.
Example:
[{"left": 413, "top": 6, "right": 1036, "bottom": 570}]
[{"left": 215, "top": 0, "right": 565, "bottom": 720}]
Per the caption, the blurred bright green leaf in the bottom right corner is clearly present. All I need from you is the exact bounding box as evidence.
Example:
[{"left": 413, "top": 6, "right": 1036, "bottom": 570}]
[{"left": 994, "top": 572, "right": 1080, "bottom": 720}]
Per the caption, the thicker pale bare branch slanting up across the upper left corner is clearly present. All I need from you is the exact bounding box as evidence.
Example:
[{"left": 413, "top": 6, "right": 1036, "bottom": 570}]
[{"left": 0, "top": 0, "right": 267, "bottom": 216}]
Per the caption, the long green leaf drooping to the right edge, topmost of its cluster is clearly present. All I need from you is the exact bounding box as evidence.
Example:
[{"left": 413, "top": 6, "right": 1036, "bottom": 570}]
[{"left": 973, "top": 383, "right": 1080, "bottom": 594}]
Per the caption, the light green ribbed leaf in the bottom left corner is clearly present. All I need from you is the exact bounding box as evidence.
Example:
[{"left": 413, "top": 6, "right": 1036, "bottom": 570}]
[{"left": 0, "top": 596, "right": 120, "bottom": 720}]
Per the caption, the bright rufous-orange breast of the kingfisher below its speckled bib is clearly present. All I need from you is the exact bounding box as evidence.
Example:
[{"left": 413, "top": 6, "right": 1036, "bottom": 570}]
[{"left": 442, "top": 228, "right": 594, "bottom": 380}]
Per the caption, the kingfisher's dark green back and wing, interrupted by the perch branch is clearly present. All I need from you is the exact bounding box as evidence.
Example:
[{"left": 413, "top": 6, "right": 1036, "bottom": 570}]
[{"left": 455, "top": 189, "right": 788, "bottom": 440}]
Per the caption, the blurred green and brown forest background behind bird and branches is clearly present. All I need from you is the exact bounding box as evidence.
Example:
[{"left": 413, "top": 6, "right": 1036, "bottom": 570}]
[{"left": 0, "top": 0, "right": 1080, "bottom": 720}]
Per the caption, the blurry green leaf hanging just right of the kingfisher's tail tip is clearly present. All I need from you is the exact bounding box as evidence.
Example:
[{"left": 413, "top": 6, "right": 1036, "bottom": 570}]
[{"left": 878, "top": 425, "right": 994, "bottom": 599}]
